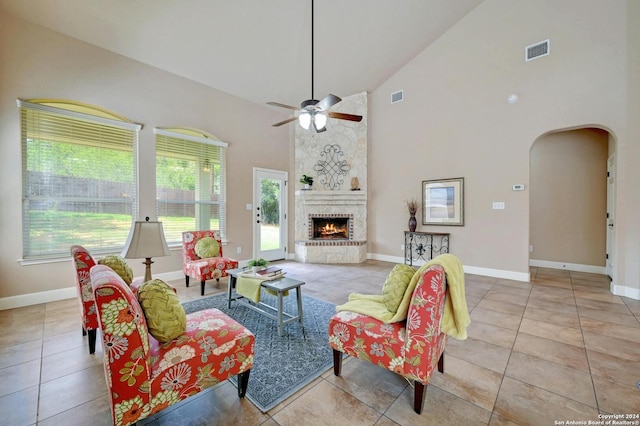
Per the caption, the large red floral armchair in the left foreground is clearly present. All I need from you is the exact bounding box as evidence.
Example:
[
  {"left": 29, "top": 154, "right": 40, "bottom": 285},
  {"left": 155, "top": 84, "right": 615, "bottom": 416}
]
[{"left": 90, "top": 265, "right": 255, "bottom": 426}]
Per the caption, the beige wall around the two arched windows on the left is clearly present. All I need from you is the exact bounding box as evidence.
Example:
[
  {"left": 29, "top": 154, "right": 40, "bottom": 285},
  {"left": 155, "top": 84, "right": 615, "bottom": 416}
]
[{"left": 0, "top": 16, "right": 289, "bottom": 298}]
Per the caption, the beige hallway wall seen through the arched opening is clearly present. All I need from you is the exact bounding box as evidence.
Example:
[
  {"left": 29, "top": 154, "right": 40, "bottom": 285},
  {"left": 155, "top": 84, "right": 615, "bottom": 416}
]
[{"left": 529, "top": 129, "right": 609, "bottom": 268}]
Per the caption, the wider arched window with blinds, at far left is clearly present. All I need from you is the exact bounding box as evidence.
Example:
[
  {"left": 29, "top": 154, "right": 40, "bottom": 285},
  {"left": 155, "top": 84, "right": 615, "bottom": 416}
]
[{"left": 18, "top": 100, "right": 141, "bottom": 260}]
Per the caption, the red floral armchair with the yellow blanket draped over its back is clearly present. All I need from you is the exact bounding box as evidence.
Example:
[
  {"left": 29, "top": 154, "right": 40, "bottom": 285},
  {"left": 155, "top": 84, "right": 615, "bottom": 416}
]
[{"left": 329, "top": 265, "right": 448, "bottom": 414}]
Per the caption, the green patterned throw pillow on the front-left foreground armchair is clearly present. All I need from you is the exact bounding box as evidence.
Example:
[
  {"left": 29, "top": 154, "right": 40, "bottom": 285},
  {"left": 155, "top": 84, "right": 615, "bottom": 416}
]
[{"left": 138, "top": 280, "right": 187, "bottom": 343}]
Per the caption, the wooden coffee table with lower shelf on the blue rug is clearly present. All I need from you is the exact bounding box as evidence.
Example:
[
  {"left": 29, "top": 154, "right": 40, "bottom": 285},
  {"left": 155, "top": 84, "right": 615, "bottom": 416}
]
[{"left": 227, "top": 268, "right": 304, "bottom": 336}]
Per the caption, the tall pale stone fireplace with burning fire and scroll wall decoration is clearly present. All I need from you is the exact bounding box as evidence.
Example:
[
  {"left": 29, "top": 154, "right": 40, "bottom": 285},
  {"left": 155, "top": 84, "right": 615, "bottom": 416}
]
[{"left": 294, "top": 92, "right": 367, "bottom": 263}]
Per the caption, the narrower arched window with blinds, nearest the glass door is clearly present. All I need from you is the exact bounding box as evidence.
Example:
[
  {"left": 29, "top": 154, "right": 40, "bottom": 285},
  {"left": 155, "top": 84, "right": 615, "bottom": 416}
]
[{"left": 154, "top": 128, "right": 228, "bottom": 244}]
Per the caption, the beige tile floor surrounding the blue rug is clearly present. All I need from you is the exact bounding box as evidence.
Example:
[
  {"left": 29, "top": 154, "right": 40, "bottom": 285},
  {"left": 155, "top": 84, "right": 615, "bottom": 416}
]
[{"left": 0, "top": 261, "right": 640, "bottom": 426}]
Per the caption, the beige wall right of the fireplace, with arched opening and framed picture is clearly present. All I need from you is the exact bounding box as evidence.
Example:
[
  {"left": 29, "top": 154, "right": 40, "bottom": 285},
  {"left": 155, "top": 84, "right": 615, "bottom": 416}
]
[{"left": 368, "top": 0, "right": 640, "bottom": 297}]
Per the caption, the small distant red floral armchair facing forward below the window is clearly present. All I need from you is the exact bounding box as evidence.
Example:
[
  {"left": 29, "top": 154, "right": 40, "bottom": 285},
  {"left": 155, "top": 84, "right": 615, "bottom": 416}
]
[{"left": 182, "top": 230, "right": 238, "bottom": 296}]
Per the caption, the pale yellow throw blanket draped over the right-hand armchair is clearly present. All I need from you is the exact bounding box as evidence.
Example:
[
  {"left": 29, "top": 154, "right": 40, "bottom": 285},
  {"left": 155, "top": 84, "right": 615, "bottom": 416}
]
[{"left": 336, "top": 253, "right": 471, "bottom": 340}]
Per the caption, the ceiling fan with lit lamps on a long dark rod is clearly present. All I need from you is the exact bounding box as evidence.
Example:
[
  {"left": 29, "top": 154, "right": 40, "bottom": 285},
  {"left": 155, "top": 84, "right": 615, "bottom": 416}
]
[{"left": 267, "top": 0, "right": 362, "bottom": 133}]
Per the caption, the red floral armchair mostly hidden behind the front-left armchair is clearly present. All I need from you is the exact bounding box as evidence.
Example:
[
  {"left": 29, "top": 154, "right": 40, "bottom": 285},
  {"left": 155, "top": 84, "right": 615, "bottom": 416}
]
[{"left": 71, "top": 245, "right": 99, "bottom": 354}]
